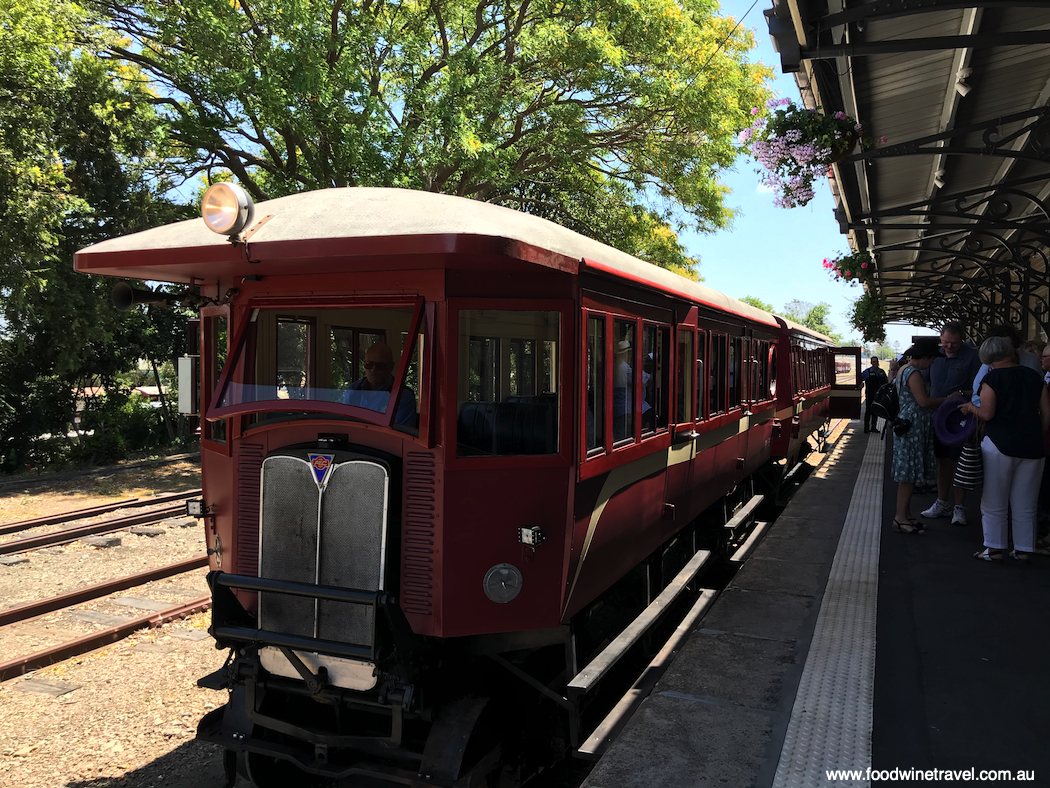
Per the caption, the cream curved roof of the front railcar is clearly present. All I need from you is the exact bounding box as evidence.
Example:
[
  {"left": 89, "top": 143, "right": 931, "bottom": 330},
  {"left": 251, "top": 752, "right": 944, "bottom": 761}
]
[{"left": 75, "top": 187, "right": 777, "bottom": 326}]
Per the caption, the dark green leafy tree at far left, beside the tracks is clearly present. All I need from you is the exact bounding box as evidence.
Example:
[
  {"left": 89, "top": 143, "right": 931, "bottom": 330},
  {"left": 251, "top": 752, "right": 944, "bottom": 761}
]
[{"left": 0, "top": 0, "right": 191, "bottom": 471}]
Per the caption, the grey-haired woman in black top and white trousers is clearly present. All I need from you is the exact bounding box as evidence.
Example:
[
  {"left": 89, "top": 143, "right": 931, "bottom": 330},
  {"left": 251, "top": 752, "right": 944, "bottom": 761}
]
[{"left": 959, "top": 336, "right": 1050, "bottom": 561}]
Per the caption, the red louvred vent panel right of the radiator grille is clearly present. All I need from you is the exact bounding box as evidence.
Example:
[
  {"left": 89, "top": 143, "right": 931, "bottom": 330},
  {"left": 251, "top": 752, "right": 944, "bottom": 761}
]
[{"left": 401, "top": 452, "right": 437, "bottom": 616}]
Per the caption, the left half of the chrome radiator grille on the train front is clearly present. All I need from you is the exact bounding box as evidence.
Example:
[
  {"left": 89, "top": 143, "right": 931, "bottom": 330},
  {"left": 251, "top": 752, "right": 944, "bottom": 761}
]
[{"left": 259, "top": 456, "right": 320, "bottom": 637}]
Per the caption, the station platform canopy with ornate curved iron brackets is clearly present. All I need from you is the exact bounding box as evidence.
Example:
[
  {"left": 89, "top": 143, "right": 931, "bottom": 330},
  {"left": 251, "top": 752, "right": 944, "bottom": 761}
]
[{"left": 765, "top": 0, "right": 1050, "bottom": 338}]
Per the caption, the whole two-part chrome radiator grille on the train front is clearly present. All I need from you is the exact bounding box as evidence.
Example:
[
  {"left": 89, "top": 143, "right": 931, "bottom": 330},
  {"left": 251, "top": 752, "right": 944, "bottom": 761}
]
[{"left": 259, "top": 452, "right": 390, "bottom": 645}]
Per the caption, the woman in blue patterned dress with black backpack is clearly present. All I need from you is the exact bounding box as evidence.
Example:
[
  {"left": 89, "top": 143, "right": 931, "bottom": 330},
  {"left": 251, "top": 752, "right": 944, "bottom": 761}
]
[{"left": 891, "top": 336, "right": 947, "bottom": 534}]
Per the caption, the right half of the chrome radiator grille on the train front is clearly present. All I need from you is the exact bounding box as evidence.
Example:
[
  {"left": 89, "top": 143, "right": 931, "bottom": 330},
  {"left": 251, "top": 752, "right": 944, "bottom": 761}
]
[{"left": 317, "top": 460, "right": 389, "bottom": 643}]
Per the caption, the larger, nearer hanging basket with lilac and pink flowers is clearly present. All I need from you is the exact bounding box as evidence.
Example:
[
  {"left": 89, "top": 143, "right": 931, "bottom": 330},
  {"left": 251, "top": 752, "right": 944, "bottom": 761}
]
[{"left": 739, "top": 99, "right": 868, "bottom": 208}]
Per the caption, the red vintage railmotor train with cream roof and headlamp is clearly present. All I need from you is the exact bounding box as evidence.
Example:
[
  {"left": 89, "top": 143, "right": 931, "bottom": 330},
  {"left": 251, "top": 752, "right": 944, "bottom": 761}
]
[{"left": 75, "top": 183, "right": 846, "bottom": 786}]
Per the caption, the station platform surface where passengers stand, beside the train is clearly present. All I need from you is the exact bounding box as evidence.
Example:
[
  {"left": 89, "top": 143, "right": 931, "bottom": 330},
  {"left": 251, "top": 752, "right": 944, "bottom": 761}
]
[{"left": 584, "top": 421, "right": 1050, "bottom": 788}]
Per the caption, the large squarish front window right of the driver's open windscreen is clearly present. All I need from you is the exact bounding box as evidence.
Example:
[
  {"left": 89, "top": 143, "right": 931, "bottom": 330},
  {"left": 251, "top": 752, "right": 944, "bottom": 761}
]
[{"left": 457, "top": 309, "right": 561, "bottom": 457}]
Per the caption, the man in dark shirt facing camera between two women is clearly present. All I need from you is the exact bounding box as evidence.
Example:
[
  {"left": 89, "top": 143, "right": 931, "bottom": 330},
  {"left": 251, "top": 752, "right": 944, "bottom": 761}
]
[{"left": 922, "top": 323, "right": 981, "bottom": 525}]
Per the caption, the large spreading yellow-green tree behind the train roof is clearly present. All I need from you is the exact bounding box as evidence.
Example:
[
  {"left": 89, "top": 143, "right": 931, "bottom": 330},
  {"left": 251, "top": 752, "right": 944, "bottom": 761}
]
[{"left": 99, "top": 0, "right": 772, "bottom": 273}]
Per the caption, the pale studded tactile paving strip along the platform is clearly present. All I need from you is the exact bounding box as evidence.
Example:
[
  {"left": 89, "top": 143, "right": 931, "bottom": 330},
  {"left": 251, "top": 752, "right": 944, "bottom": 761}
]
[{"left": 773, "top": 432, "right": 885, "bottom": 788}]
